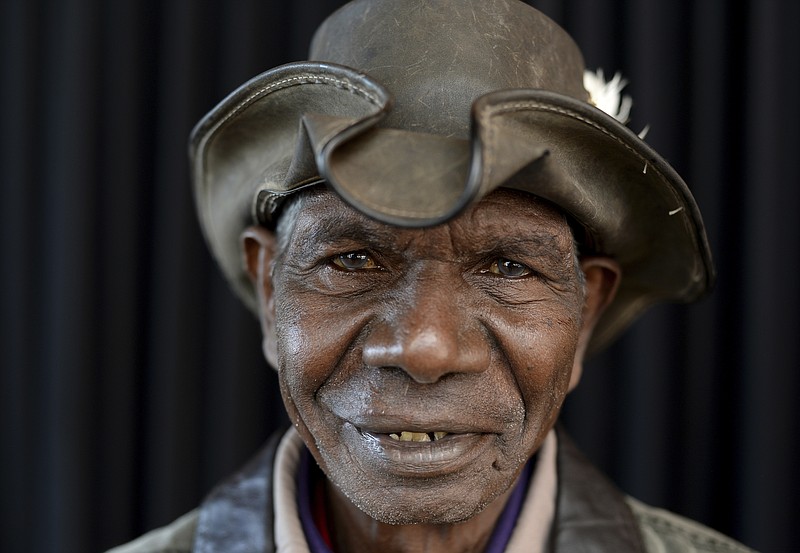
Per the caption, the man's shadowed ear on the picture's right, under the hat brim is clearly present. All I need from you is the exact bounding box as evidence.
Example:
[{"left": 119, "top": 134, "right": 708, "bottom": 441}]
[{"left": 569, "top": 256, "right": 622, "bottom": 391}]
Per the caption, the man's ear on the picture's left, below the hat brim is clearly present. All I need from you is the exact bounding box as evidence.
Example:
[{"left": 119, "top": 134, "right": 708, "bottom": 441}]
[{"left": 241, "top": 226, "right": 278, "bottom": 368}]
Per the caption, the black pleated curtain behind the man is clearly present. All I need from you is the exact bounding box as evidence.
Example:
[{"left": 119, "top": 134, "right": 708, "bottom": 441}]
[{"left": 0, "top": 0, "right": 800, "bottom": 552}]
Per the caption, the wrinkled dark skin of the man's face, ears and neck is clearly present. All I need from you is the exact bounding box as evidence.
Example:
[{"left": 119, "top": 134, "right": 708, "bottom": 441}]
[{"left": 243, "top": 190, "right": 619, "bottom": 553}]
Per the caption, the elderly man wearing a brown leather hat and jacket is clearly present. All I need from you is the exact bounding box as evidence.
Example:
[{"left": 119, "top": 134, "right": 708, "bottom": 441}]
[{"left": 109, "top": 0, "right": 745, "bottom": 552}]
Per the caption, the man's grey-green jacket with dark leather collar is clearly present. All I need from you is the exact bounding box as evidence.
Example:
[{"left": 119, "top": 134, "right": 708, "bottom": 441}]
[{"left": 109, "top": 431, "right": 751, "bottom": 553}]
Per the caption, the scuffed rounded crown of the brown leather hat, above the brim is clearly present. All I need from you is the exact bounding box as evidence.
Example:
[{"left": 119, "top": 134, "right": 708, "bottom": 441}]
[{"left": 310, "top": 0, "right": 587, "bottom": 138}]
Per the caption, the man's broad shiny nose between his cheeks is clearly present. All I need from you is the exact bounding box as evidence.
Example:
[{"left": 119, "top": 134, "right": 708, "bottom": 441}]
[{"left": 363, "top": 278, "right": 491, "bottom": 383}]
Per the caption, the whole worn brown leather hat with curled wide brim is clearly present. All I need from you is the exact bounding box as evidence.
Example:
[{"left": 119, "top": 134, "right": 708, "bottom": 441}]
[{"left": 190, "top": 0, "right": 714, "bottom": 351}]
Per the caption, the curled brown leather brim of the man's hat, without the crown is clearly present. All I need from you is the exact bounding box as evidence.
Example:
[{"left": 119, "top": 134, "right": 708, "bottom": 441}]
[{"left": 190, "top": 63, "right": 714, "bottom": 353}]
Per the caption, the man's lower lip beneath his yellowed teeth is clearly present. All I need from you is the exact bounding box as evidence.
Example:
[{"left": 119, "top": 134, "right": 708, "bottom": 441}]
[{"left": 345, "top": 423, "right": 495, "bottom": 478}]
